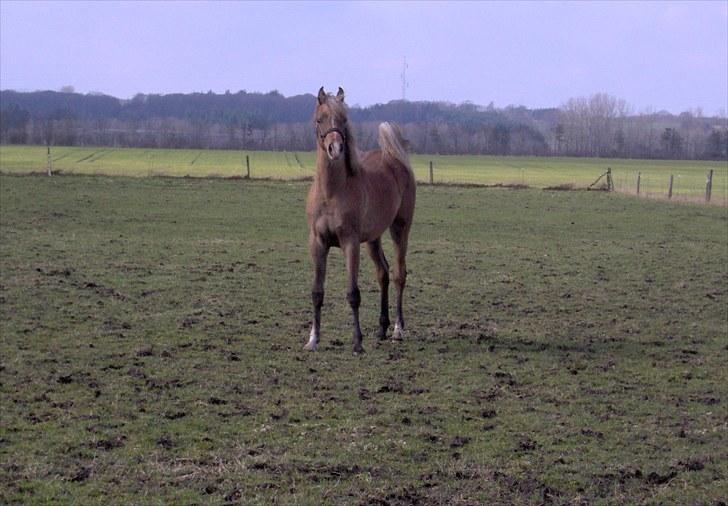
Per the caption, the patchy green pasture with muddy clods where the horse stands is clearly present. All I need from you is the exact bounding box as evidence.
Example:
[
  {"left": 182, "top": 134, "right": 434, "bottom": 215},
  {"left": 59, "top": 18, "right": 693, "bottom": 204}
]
[{"left": 0, "top": 175, "right": 728, "bottom": 505}]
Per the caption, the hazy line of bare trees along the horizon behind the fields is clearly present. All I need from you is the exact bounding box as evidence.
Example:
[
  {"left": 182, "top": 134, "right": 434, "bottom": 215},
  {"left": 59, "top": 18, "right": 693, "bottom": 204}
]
[{"left": 0, "top": 89, "right": 728, "bottom": 160}]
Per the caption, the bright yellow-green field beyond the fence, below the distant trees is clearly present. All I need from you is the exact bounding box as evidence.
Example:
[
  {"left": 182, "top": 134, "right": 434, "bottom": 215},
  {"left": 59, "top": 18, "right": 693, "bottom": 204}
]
[{"left": 0, "top": 146, "right": 728, "bottom": 204}]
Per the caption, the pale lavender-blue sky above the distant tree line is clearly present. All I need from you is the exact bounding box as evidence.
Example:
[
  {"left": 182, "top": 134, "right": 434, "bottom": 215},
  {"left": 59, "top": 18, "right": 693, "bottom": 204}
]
[{"left": 0, "top": 0, "right": 728, "bottom": 115}]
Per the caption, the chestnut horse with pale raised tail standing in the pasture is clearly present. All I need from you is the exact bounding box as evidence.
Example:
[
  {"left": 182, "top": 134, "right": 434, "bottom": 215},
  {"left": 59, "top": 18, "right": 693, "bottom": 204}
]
[{"left": 304, "top": 87, "right": 415, "bottom": 353}]
